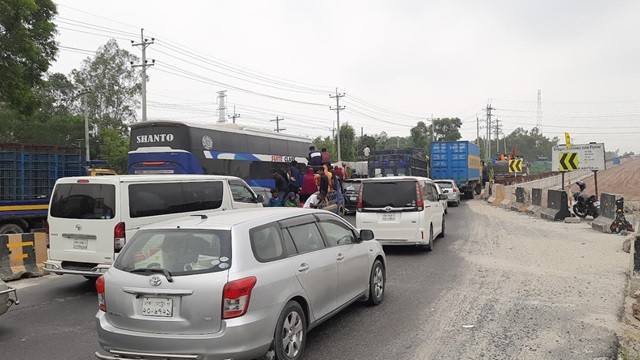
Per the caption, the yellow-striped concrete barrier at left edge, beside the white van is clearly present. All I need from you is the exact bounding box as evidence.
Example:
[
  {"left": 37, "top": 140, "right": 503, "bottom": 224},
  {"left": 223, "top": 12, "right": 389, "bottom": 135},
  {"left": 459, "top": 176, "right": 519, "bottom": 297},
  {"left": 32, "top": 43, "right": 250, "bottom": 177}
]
[{"left": 0, "top": 233, "right": 47, "bottom": 281}]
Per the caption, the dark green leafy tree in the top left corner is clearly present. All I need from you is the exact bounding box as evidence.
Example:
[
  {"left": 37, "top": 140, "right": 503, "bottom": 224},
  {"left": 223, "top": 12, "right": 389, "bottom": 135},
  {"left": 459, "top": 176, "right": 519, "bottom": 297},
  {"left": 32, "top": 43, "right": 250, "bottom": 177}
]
[{"left": 0, "top": 0, "right": 58, "bottom": 114}]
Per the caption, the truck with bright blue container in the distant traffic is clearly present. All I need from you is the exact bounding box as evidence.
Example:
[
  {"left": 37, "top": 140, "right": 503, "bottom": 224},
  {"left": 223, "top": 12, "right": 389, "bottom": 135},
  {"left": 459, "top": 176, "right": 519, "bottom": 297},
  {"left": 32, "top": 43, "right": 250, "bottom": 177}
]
[{"left": 431, "top": 141, "right": 482, "bottom": 199}]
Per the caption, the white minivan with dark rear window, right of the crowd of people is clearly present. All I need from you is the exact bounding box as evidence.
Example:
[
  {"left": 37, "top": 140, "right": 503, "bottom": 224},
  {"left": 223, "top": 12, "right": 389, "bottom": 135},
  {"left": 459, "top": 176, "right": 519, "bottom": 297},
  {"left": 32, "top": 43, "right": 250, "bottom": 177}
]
[{"left": 356, "top": 176, "right": 447, "bottom": 251}]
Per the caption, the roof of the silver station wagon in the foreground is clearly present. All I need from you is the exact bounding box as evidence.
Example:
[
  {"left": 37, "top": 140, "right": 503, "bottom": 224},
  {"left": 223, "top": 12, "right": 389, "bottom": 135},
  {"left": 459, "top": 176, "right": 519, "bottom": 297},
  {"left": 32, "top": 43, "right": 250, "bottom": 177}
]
[{"left": 144, "top": 207, "right": 331, "bottom": 230}]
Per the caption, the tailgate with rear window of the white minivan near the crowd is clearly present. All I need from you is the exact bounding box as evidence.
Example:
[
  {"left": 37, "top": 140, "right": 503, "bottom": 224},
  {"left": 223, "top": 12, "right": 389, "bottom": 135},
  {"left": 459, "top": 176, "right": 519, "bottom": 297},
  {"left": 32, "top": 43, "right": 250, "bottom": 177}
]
[{"left": 358, "top": 179, "right": 422, "bottom": 240}]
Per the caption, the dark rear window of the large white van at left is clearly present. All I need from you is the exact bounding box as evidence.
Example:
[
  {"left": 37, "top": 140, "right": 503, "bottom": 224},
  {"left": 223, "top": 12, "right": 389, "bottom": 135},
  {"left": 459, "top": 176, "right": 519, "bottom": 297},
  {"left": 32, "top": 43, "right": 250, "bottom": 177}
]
[{"left": 50, "top": 183, "right": 116, "bottom": 219}]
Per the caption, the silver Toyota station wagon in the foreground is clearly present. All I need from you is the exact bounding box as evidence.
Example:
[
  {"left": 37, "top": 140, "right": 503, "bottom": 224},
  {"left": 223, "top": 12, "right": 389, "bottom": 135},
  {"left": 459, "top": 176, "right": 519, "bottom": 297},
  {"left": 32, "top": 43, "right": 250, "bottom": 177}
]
[{"left": 96, "top": 208, "right": 386, "bottom": 360}]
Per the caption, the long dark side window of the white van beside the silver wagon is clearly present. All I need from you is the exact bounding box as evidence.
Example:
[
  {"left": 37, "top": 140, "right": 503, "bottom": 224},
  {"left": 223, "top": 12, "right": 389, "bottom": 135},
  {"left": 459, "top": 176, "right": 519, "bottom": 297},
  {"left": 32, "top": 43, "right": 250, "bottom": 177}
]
[{"left": 129, "top": 181, "right": 223, "bottom": 218}]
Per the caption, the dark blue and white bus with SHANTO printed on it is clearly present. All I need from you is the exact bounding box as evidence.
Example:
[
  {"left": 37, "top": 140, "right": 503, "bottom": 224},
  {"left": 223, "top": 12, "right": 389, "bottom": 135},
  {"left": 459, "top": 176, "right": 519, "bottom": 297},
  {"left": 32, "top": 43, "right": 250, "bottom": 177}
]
[{"left": 127, "top": 120, "right": 313, "bottom": 188}]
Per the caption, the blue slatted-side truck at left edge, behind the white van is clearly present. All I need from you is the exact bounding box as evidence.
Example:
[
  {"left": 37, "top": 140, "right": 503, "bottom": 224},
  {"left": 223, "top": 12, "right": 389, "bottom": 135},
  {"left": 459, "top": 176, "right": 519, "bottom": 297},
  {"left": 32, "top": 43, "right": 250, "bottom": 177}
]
[{"left": 0, "top": 143, "right": 87, "bottom": 235}]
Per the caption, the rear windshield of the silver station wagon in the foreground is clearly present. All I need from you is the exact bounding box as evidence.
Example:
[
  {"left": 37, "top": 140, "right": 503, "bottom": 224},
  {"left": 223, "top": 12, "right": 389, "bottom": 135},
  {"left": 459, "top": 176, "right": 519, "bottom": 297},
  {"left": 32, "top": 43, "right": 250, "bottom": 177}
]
[{"left": 113, "top": 229, "right": 231, "bottom": 275}]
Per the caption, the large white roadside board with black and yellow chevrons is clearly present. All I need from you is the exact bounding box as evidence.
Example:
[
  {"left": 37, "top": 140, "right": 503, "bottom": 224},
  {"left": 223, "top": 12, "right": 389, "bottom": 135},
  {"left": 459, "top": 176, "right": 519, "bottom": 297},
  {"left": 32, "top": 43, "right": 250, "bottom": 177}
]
[{"left": 551, "top": 143, "right": 606, "bottom": 171}]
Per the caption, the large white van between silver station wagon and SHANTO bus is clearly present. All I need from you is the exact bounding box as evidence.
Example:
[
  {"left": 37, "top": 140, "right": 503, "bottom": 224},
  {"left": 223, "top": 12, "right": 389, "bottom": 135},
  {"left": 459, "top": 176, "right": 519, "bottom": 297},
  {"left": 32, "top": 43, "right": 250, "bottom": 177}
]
[{"left": 44, "top": 175, "right": 263, "bottom": 278}]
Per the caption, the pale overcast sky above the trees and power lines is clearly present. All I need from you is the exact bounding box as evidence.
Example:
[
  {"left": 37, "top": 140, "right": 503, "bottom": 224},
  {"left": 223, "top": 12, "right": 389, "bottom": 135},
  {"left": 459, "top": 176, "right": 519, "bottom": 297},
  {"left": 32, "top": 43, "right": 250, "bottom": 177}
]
[{"left": 49, "top": 0, "right": 640, "bottom": 154}]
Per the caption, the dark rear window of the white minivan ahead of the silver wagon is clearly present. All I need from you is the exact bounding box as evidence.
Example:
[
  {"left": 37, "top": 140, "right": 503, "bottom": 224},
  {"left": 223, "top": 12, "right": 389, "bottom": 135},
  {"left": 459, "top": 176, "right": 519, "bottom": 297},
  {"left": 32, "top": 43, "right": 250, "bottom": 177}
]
[{"left": 362, "top": 180, "right": 416, "bottom": 208}]
